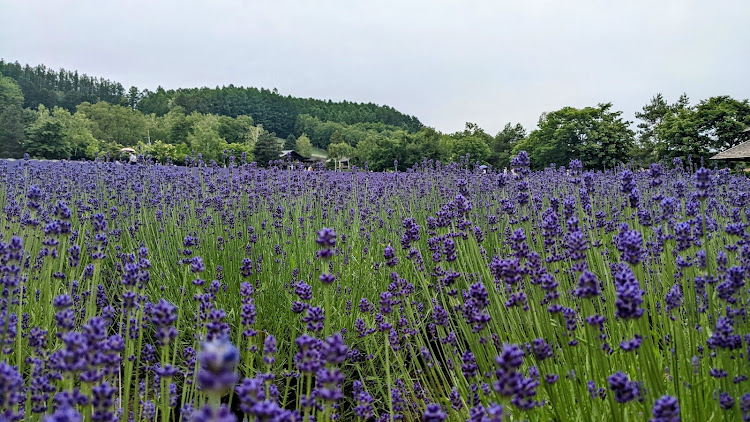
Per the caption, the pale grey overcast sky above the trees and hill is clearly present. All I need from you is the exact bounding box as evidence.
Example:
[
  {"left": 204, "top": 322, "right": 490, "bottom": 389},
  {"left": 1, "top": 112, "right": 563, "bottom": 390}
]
[{"left": 0, "top": 0, "right": 750, "bottom": 134}]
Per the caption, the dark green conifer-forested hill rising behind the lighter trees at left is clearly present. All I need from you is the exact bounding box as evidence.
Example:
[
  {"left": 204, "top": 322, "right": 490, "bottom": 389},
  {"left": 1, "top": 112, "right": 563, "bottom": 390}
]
[{"left": 0, "top": 60, "right": 423, "bottom": 138}]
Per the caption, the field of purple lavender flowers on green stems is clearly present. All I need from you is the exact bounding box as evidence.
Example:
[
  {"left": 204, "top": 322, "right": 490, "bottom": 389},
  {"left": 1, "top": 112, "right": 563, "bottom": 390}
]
[{"left": 0, "top": 153, "right": 750, "bottom": 422}]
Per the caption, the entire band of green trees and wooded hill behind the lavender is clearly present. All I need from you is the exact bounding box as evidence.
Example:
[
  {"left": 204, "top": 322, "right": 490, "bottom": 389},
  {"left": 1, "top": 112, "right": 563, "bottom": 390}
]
[{"left": 0, "top": 61, "right": 750, "bottom": 171}]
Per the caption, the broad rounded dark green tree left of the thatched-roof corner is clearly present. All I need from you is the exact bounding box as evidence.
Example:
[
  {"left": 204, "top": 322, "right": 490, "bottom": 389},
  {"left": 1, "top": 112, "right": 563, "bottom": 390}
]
[{"left": 512, "top": 103, "right": 634, "bottom": 169}]
